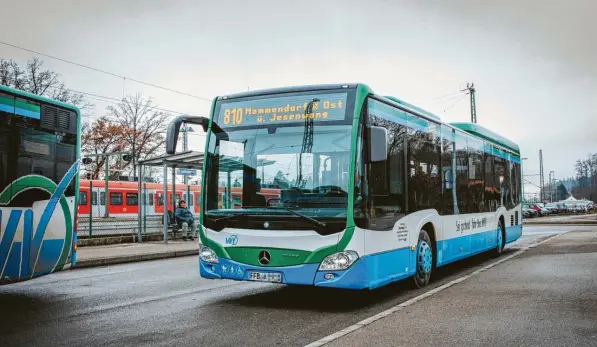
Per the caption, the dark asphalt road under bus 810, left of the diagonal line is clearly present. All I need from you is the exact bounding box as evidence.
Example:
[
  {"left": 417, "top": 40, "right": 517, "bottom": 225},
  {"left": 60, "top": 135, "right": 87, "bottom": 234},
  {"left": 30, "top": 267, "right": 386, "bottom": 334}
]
[{"left": 0, "top": 226, "right": 589, "bottom": 347}]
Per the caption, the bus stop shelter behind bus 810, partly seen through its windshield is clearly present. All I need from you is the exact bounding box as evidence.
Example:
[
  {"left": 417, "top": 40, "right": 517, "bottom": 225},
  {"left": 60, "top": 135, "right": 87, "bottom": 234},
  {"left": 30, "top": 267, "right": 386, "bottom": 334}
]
[{"left": 137, "top": 151, "right": 275, "bottom": 243}]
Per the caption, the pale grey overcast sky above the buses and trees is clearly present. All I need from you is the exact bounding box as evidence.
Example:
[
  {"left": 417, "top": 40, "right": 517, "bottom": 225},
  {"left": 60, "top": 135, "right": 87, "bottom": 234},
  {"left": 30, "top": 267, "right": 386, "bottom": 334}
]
[{"left": 0, "top": 0, "right": 597, "bottom": 191}]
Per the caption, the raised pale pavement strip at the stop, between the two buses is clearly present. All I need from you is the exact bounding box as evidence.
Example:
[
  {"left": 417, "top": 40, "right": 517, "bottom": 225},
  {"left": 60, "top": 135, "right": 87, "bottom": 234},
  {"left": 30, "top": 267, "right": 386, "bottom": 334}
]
[{"left": 75, "top": 241, "right": 199, "bottom": 268}]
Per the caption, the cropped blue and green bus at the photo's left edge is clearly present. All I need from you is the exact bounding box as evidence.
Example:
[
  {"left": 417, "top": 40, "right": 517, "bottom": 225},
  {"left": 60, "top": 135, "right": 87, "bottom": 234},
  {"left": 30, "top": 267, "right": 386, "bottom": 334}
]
[{"left": 0, "top": 86, "right": 80, "bottom": 284}]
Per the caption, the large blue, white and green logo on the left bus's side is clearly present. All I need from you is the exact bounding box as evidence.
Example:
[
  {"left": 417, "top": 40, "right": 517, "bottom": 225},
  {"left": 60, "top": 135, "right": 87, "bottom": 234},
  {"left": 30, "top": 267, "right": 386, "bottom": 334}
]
[{"left": 0, "top": 161, "right": 79, "bottom": 281}]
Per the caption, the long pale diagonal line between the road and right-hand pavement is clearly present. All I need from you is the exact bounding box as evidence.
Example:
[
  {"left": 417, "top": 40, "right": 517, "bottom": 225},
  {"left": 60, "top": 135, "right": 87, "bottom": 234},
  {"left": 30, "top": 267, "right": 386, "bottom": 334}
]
[{"left": 305, "top": 231, "right": 568, "bottom": 347}]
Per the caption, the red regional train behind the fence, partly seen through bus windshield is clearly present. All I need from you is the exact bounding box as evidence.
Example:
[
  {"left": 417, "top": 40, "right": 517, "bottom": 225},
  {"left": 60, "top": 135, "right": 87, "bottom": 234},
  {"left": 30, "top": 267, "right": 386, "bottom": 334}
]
[{"left": 77, "top": 179, "right": 280, "bottom": 217}]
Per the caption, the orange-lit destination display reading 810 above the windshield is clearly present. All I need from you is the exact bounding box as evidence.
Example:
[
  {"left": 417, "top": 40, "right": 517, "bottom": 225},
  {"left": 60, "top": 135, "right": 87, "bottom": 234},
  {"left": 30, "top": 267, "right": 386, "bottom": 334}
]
[{"left": 216, "top": 93, "right": 347, "bottom": 128}]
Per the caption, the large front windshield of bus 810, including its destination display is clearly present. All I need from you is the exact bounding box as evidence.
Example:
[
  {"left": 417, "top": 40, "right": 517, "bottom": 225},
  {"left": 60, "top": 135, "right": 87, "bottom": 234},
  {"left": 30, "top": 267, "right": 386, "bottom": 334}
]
[{"left": 205, "top": 91, "right": 352, "bottom": 231}]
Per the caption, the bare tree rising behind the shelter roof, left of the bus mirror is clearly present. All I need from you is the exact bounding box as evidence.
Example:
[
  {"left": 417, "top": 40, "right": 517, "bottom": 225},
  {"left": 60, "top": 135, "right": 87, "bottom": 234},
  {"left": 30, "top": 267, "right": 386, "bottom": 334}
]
[{"left": 106, "top": 93, "right": 169, "bottom": 174}]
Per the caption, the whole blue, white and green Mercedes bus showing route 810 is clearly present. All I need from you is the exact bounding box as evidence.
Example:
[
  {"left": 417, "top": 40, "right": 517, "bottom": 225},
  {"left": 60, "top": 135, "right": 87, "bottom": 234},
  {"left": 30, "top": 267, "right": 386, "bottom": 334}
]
[{"left": 166, "top": 84, "right": 522, "bottom": 289}]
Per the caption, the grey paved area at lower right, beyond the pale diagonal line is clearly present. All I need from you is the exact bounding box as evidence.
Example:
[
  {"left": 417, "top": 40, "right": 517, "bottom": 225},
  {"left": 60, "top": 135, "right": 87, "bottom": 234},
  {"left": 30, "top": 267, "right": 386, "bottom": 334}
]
[{"left": 316, "top": 228, "right": 597, "bottom": 347}]
